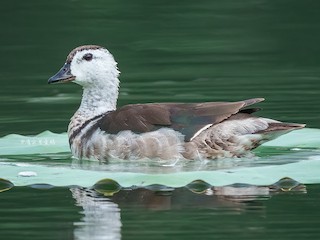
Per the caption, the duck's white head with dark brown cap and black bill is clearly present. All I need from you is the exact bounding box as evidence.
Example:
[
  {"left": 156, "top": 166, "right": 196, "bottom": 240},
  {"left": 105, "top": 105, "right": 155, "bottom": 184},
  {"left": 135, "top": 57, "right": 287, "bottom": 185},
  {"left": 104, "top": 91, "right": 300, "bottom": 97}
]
[{"left": 48, "top": 45, "right": 119, "bottom": 88}]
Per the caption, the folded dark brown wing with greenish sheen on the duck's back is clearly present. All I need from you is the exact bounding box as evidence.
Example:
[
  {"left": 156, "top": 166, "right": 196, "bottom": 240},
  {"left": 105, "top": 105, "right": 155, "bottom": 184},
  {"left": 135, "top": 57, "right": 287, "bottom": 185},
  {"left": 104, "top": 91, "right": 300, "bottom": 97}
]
[{"left": 98, "top": 98, "right": 264, "bottom": 141}]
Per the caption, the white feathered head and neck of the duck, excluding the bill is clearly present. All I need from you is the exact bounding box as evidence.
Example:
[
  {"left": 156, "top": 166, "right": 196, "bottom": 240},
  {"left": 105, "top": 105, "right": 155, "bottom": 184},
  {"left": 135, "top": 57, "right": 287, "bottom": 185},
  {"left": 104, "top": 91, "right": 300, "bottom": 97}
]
[{"left": 68, "top": 47, "right": 120, "bottom": 118}]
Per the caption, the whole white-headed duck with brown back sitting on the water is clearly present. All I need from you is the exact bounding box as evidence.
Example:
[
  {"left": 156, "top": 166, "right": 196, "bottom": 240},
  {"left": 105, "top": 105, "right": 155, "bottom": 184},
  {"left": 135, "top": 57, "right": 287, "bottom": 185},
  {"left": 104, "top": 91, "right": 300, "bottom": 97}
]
[{"left": 48, "top": 45, "right": 305, "bottom": 161}]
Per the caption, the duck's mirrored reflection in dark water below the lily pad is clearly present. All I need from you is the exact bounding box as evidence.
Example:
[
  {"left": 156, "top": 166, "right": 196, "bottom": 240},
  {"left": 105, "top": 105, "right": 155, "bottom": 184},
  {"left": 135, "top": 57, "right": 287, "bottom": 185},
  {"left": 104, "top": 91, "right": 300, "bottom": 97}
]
[{"left": 71, "top": 178, "right": 306, "bottom": 240}]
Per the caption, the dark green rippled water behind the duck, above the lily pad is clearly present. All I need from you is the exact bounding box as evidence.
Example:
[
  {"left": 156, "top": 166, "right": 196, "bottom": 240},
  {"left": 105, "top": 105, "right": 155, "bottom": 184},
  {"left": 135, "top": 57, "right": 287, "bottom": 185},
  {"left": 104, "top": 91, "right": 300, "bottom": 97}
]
[{"left": 0, "top": 0, "right": 320, "bottom": 136}]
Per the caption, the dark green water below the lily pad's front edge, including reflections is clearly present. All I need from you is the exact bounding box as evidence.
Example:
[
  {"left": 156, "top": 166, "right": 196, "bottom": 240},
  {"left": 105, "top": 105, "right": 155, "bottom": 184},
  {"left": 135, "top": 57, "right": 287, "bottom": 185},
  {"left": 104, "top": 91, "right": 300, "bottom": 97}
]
[{"left": 0, "top": 185, "right": 320, "bottom": 240}]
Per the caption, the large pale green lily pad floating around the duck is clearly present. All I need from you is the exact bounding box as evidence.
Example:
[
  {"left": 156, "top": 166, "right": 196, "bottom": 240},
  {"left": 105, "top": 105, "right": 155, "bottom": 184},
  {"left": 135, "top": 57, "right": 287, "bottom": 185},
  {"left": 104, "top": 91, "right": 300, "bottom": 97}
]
[{"left": 0, "top": 129, "right": 320, "bottom": 188}]
